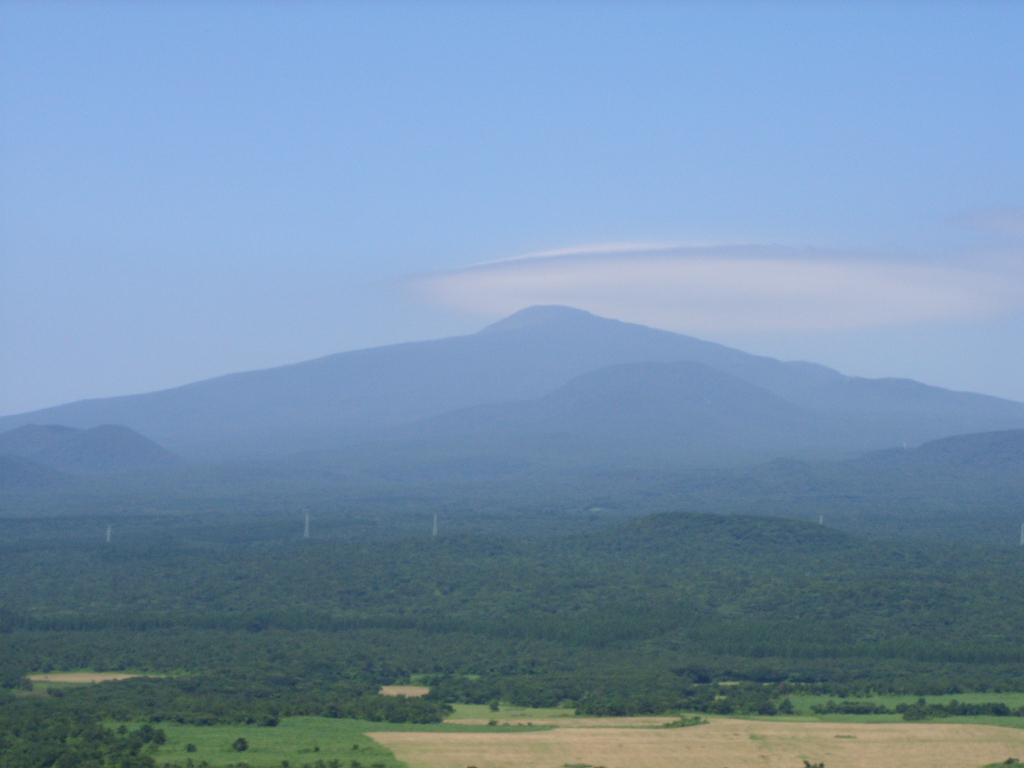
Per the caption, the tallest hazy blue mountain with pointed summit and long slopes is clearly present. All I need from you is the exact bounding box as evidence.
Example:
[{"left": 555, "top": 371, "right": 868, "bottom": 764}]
[{"left": 0, "top": 306, "right": 1024, "bottom": 458}]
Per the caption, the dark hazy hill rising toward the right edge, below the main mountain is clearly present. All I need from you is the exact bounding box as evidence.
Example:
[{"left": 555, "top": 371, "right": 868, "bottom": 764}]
[{"left": 663, "top": 429, "right": 1024, "bottom": 544}]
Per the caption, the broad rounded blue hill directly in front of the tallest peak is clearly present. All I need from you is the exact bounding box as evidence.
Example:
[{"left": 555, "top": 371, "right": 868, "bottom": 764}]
[{"left": 319, "top": 361, "right": 858, "bottom": 479}]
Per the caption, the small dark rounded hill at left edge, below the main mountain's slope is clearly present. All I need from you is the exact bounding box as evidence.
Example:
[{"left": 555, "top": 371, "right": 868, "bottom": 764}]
[{"left": 0, "top": 424, "right": 180, "bottom": 474}]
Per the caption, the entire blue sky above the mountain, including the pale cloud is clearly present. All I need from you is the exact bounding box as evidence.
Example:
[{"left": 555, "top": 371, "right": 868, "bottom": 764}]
[{"left": 0, "top": 0, "right": 1024, "bottom": 413}]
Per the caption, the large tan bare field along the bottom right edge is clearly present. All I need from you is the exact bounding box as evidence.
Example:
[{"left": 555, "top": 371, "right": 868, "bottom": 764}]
[{"left": 367, "top": 718, "right": 1024, "bottom": 768}]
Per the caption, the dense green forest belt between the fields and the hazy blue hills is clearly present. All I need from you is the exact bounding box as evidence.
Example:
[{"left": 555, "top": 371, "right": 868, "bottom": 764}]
[{"left": 0, "top": 513, "right": 1024, "bottom": 723}]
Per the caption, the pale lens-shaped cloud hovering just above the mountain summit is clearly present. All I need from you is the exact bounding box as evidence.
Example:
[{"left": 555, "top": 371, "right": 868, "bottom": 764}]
[{"left": 412, "top": 244, "right": 1024, "bottom": 333}]
